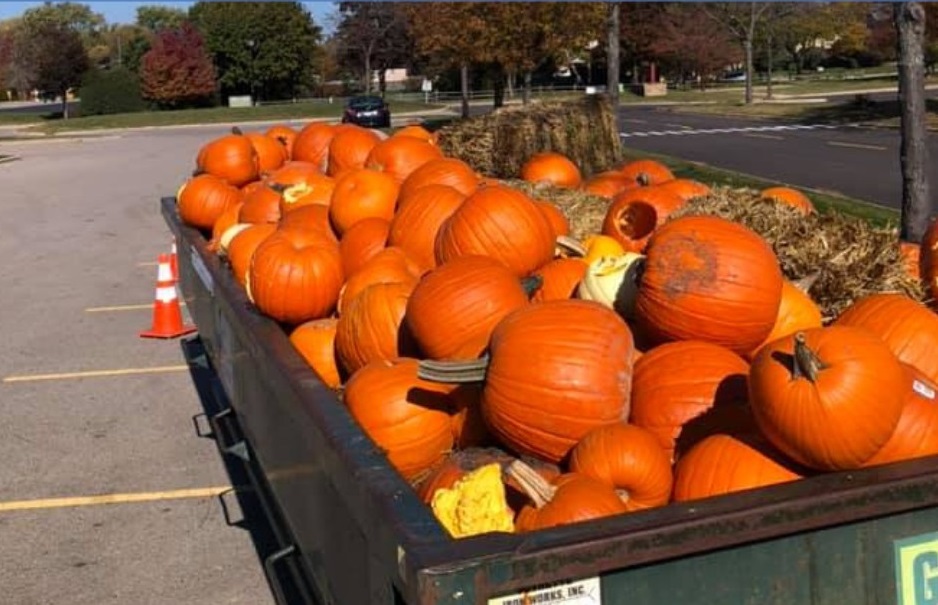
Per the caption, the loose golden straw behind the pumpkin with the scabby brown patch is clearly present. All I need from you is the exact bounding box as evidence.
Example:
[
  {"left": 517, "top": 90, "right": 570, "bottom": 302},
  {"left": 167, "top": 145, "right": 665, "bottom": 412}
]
[{"left": 671, "top": 187, "right": 926, "bottom": 323}]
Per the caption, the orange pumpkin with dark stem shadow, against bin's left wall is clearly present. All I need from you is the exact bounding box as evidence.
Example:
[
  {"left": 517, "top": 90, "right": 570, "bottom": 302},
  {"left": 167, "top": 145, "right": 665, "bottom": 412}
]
[{"left": 343, "top": 359, "right": 453, "bottom": 480}]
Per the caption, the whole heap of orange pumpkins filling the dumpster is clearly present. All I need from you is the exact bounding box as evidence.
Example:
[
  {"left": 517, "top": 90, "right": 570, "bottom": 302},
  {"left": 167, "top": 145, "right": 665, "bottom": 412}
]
[{"left": 177, "top": 123, "right": 938, "bottom": 537}]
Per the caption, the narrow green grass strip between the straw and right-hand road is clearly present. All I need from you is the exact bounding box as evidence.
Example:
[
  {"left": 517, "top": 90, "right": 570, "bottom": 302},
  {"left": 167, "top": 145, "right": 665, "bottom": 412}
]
[{"left": 623, "top": 147, "right": 899, "bottom": 226}]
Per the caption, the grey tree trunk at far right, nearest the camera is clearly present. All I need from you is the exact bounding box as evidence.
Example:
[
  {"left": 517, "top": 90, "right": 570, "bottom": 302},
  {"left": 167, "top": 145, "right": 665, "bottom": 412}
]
[{"left": 893, "top": 2, "right": 938, "bottom": 243}]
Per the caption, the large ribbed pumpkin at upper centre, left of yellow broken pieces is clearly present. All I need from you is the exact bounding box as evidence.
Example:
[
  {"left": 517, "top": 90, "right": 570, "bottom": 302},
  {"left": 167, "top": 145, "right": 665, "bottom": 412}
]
[{"left": 435, "top": 186, "right": 555, "bottom": 277}]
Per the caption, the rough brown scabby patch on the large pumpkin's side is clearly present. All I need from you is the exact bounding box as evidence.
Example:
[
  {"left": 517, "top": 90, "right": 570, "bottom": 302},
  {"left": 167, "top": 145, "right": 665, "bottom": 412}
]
[{"left": 655, "top": 235, "right": 719, "bottom": 298}]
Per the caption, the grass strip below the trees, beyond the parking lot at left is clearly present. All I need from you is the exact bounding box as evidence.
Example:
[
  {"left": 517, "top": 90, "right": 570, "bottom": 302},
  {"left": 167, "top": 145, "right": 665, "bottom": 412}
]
[{"left": 0, "top": 101, "right": 440, "bottom": 133}]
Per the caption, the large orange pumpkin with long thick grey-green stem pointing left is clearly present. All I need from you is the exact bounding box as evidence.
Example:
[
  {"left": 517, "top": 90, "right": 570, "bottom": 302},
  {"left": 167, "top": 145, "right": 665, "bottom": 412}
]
[{"left": 421, "top": 300, "right": 634, "bottom": 462}]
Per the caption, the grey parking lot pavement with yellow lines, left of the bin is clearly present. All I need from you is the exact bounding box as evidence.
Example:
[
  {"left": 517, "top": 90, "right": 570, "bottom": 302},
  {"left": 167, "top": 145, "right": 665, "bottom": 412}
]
[{"left": 0, "top": 131, "right": 273, "bottom": 605}]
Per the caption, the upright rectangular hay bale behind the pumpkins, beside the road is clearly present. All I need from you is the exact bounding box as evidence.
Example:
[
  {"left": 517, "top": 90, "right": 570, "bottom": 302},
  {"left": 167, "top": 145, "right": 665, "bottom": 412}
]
[{"left": 438, "top": 95, "right": 622, "bottom": 179}]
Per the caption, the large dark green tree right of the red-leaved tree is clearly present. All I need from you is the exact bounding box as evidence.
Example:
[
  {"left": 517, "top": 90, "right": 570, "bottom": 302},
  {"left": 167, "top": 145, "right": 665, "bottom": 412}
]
[{"left": 189, "top": 2, "right": 321, "bottom": 99}]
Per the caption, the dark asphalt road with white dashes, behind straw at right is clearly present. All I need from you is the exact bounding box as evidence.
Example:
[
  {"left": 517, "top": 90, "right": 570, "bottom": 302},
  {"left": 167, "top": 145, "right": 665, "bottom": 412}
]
[{"left": 620, "top": 107, "right": 938, "bottom": 208}]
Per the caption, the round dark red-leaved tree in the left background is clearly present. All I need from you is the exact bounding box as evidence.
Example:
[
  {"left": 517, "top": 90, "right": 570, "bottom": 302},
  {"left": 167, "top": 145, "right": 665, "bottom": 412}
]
[{"left": 140, "top": 23, "right": 216, "bottom": 109}]
